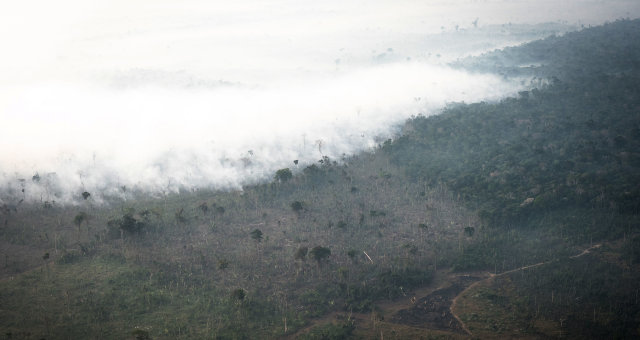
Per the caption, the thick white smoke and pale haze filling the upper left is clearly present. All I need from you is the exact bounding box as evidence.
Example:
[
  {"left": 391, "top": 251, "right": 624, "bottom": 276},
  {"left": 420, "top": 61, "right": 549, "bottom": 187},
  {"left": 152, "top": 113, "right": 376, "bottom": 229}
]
[{"left": 0, "top": 0, "right": 640, "bottom": 203}]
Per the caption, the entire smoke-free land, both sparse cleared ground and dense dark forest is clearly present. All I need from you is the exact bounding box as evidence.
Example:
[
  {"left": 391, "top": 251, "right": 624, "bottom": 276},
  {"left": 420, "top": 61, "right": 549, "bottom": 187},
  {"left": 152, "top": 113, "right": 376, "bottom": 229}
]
[{"left": 0, "top": 20, "right": 640, "bottom": 339}]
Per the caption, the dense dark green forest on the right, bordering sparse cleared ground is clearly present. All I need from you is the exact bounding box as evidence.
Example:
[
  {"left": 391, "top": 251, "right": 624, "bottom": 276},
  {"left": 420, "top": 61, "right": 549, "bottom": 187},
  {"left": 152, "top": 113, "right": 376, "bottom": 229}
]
[{"left": 383, "top": 20, "right": 640, "bottom": 268}]
